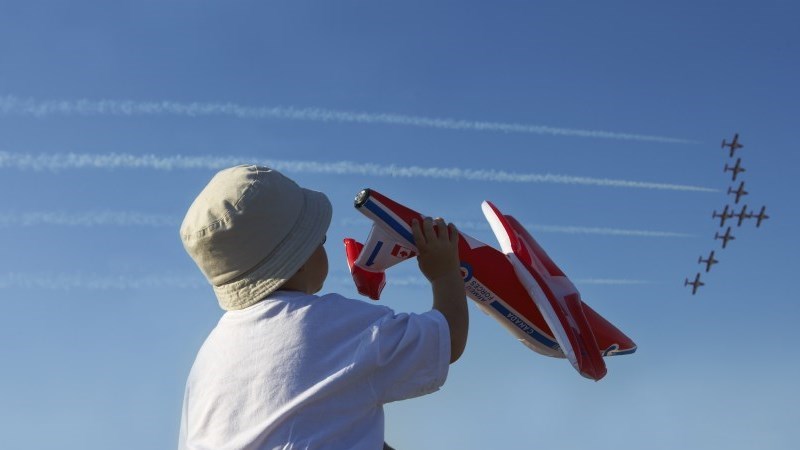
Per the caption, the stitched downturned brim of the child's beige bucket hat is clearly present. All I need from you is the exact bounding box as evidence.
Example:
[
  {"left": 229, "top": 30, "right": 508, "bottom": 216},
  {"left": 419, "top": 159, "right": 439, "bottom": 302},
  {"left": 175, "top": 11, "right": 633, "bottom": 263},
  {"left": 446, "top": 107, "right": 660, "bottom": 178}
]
[{"left": 214, "top": 189, "right": 333, "bottom": 311}]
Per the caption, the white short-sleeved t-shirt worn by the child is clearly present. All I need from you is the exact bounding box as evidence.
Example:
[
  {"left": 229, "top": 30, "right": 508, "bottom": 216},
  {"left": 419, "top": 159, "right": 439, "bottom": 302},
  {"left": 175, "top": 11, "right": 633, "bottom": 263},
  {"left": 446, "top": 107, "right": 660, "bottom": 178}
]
[{"left": 179, "top": 291, "right": 450, "bottom": 450}]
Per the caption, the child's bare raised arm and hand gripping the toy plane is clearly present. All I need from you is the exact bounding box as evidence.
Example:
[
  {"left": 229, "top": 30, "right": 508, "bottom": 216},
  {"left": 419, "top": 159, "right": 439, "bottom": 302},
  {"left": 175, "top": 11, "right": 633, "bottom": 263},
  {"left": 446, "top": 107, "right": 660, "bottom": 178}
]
[{"left": 411, "top": 217, "right": 469, "bottom": 364}]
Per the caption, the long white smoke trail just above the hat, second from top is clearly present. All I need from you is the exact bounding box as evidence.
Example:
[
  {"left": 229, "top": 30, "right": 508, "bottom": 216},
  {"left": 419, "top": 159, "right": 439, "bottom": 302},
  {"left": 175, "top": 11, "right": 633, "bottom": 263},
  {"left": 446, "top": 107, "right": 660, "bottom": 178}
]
[{"left": 0, "top": 152, "right": 719, "bottom": 192}]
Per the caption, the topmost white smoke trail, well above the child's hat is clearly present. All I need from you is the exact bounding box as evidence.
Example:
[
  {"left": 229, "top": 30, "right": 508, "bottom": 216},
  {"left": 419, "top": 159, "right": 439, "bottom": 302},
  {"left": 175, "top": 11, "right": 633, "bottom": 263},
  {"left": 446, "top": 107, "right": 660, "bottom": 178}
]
[{"left": 0, "top": 95, "right": 697, "bottom": 144}]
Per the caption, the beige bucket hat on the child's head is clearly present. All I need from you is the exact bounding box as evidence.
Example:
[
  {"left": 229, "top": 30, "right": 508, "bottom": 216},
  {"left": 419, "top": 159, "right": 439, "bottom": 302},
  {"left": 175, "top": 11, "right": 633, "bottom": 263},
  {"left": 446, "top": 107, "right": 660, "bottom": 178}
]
[{"left": 180, "top": 165, "right": 332, "bottom": 310}]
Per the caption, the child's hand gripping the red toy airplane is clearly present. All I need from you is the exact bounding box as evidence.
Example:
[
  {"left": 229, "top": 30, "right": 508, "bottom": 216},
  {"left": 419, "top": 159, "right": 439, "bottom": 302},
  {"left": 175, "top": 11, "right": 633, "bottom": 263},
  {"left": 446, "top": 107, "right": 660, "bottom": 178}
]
[{"left": 411, "top": 217, "right": 461, "bottom": 282}]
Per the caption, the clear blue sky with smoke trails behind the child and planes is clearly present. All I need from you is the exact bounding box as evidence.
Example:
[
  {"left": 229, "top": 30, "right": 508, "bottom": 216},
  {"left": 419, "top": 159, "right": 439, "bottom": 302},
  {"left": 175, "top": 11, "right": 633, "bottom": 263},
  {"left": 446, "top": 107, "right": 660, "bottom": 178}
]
[{"left": 0, "top": 1, "right": 800, "bottom": 449}]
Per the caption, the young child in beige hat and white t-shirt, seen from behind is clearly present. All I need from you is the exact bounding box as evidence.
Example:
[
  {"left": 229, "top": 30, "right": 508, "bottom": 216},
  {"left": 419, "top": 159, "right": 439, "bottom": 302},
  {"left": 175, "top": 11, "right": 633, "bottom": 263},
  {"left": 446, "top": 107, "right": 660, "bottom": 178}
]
[{"left": 179, "top": 166, "right": 468, "bottom": 450}]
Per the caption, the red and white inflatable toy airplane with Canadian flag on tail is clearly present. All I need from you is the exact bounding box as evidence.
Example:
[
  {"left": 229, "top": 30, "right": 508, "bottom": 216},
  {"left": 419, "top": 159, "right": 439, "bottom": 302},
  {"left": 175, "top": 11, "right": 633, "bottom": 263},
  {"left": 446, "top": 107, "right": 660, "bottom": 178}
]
[{"left": 345, "top": 189, "right": 636, "bottom": 380}]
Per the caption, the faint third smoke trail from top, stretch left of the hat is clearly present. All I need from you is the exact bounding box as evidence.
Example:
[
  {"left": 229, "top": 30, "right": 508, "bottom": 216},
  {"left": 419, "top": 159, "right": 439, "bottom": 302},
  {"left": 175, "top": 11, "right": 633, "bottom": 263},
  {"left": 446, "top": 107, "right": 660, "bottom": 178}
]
[{"left": 0, "top": 211, "right": 180, "bottom": 227}]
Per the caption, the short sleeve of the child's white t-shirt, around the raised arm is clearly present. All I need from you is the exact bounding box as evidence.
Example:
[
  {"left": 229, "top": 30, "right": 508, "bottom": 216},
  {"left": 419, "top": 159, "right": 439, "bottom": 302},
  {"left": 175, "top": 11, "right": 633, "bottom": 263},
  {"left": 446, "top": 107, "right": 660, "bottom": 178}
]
[{"left": 370, "top": 309, "right": 450, "bottom": 403}]
